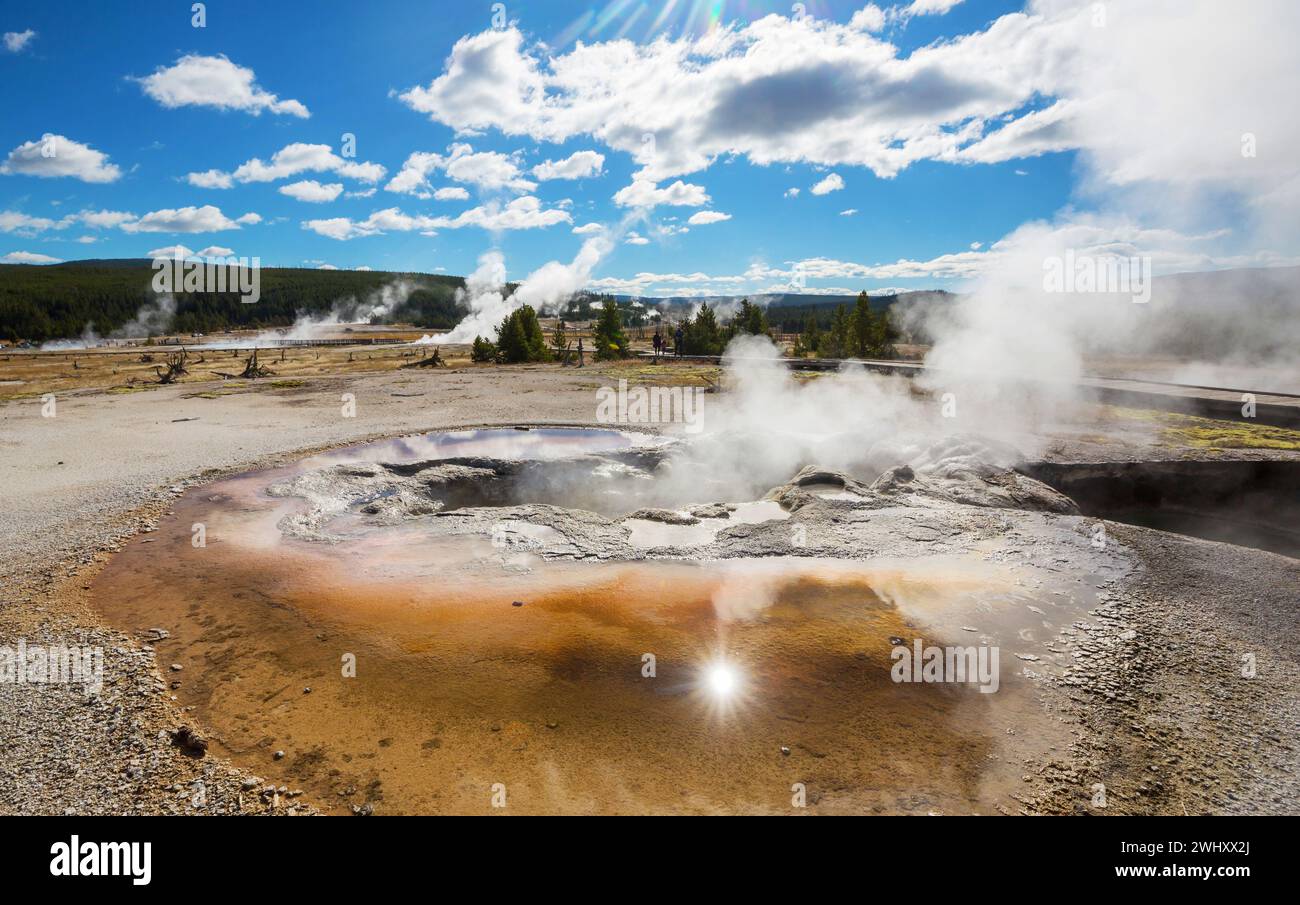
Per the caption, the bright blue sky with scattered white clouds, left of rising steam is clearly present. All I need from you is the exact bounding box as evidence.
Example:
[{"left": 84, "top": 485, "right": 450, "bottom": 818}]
[{"left": 0, "top": 0, "right": 1279, "bottom": 294}]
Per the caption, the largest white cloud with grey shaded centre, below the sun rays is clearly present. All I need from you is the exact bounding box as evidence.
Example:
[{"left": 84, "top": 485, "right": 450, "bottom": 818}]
[{"left": 399, "top": 15, "right": 1076, "bottom": 183}]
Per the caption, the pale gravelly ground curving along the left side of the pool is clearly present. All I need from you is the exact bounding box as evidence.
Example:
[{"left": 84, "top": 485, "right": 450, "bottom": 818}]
[{"left": 0, "top": 368, "right": 608, "bottom": 814}]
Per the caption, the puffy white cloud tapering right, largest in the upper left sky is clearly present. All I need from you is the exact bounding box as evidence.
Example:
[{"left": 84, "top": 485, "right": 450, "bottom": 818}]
[{"left": 135, "top": 53, "right": 311, "bottom": 120}]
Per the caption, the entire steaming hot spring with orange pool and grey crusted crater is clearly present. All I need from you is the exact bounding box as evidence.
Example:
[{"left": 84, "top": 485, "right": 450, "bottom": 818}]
[{"left": 95, "top": 405, "right": 1300, "bottom": 814}]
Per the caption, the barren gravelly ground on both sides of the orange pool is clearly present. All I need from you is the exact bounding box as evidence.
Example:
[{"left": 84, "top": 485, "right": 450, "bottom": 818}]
[{"left": 0, "top": 350, "right": 1300, "bottom": 814}]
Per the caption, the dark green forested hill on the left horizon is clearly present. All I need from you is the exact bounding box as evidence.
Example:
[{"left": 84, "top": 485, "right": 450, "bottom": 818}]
[{"left": 0, "top": 259, "right": 464, "bottom": 342}]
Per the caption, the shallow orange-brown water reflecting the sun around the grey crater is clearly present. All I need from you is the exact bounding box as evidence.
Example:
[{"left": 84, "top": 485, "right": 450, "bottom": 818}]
[{"left": 94, "top": 432, "right": 1087, "bottom": 813}]
